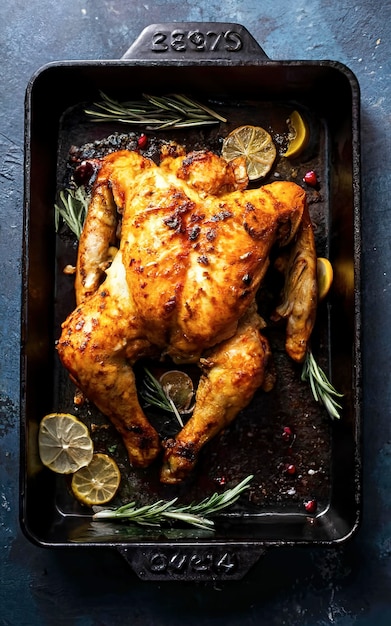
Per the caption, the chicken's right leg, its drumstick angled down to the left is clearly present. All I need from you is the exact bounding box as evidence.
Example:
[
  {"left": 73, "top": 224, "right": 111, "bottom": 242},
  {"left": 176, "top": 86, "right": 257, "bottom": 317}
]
[{"left": 160, "top": 308, "right": 274, "bottom": 484}]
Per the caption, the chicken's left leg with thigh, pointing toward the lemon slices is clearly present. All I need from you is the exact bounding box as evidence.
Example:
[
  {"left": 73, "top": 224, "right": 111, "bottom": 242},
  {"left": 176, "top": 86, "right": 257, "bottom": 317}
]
[{"left": 57, "top": 252, "right": 160, "bottom": 467}]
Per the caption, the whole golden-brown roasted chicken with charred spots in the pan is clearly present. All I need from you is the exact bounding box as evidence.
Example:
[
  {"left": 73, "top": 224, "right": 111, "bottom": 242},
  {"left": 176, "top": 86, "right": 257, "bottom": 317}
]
[{"left": 58, "top": 146, "right": 317, "bottom": 483}]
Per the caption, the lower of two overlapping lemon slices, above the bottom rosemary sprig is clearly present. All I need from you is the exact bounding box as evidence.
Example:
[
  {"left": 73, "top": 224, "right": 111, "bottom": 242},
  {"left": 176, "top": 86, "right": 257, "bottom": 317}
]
[{"left": 71, "top": 453, "right": 121, "bottom": 506}]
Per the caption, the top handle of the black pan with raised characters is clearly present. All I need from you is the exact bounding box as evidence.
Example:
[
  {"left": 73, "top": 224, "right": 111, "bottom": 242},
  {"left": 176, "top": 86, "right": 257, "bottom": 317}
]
[{"left": 122, "top": 22, "right": 268, "bottom": 64}]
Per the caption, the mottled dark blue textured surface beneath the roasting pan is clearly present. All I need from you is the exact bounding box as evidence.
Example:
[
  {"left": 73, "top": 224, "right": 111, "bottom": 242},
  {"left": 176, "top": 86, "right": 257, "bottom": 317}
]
[{"left": 0, "top": 0, "right": 391, "bottom": 626}]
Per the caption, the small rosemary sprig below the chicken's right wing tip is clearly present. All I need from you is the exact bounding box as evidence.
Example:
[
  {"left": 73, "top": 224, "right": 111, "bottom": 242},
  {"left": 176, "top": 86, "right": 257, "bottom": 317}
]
[{"left": 301, "top": 349, "right": 343, "bottom": 419}]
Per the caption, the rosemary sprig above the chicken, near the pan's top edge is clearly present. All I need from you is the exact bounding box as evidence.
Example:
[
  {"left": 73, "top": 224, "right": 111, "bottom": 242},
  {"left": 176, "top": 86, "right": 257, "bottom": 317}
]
[{"left": 84, "top": 91, "right": 227, "bottom": 130}]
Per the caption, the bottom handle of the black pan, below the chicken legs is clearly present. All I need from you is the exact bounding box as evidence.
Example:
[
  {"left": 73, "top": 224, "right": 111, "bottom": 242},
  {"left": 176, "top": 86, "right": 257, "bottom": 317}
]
[{"left": 117, "top": 544, "right": 266, "bottom": 582}]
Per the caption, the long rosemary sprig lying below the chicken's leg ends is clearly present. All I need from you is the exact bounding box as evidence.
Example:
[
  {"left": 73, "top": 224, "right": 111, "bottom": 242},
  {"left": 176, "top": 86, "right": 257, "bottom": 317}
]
[{"left": 93, "top": 475, "right": 253, "bottom": 530}]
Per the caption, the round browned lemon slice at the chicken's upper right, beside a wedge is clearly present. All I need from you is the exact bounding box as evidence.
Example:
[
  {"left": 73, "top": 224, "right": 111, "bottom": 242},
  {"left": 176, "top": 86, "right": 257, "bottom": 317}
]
[{"left": 221, "top": 125, "right": 277, "bottom": 180}]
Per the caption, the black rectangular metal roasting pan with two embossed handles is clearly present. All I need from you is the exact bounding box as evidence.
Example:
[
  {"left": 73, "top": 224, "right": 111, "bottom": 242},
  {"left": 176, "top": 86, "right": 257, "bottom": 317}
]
[{"left": 20, "top": 23, "right": 361, "bottom": 580}]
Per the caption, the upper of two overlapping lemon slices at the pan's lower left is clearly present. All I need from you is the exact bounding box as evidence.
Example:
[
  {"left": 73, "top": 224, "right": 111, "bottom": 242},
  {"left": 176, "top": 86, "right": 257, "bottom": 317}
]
[{"left": 38, "top": 413, "right": 94, "bottom": 474}]
